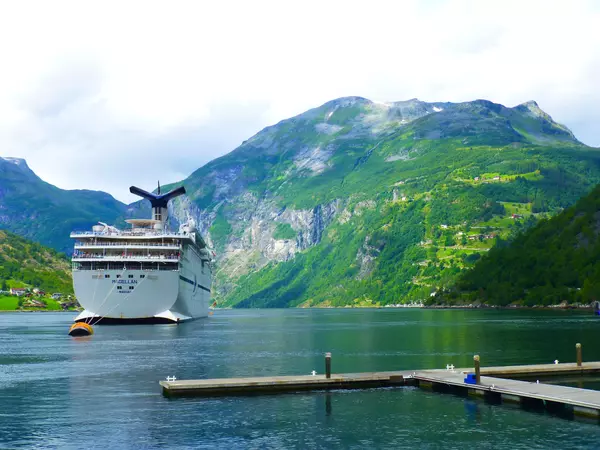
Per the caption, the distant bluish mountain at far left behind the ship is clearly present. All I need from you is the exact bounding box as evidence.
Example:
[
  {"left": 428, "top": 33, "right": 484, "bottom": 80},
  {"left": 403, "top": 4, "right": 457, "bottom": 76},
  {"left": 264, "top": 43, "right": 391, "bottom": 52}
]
[{"left": 0, "top": 157, "right": 127, "bottom": 252}]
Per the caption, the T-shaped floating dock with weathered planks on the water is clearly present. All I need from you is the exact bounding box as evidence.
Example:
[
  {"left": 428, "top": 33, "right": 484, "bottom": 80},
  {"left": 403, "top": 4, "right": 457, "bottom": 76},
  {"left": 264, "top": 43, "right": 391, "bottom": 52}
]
[{"left": 160, "top": 361, "right": 600, "bottom": 420}]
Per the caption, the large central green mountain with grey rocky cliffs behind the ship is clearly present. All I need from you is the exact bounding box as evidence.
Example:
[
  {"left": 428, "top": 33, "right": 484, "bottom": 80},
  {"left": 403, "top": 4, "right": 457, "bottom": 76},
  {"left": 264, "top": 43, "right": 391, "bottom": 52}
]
[{"left": 156, "top": 97, "right": 600, "bottom": 307}]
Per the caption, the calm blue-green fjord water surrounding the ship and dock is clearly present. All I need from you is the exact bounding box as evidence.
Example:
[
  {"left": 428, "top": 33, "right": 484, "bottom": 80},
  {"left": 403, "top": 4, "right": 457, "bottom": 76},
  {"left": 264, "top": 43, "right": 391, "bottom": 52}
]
[{"left": 0, "top": 309, "right": 600, "bottom": 449}]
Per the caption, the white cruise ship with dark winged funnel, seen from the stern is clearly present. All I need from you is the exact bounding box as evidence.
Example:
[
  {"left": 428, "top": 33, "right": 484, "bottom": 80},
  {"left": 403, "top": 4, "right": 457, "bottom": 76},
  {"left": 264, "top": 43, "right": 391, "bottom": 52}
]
[{"left": 71, "top": 185, "right": 213, "bottom": 324}]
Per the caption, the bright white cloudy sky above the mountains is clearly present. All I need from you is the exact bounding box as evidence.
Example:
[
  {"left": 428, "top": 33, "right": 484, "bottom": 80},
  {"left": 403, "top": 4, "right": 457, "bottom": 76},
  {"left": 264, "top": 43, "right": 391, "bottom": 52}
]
[{"left": 0, "top": 0, "right": 600, "bottom": 201}]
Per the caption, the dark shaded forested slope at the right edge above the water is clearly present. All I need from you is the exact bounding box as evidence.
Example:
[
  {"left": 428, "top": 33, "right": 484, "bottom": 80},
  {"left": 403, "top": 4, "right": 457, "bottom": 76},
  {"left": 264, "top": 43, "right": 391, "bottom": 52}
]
[{"left": 432, "top": 186, "right": 600, "bottom": 306}]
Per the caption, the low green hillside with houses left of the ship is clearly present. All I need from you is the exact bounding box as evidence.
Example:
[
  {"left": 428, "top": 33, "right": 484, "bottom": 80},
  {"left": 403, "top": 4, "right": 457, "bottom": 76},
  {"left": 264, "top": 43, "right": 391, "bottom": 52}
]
[{"left": 0, "top": 230, "right": 73, "bottom": 293}]
